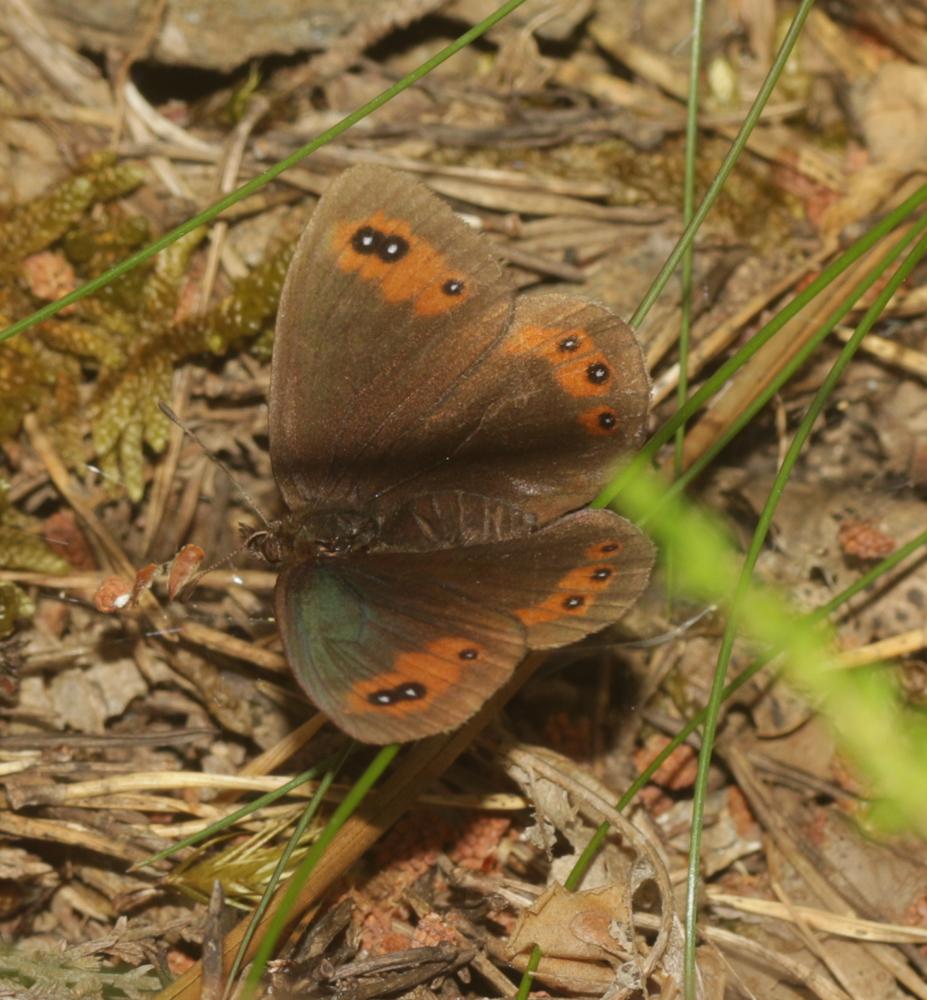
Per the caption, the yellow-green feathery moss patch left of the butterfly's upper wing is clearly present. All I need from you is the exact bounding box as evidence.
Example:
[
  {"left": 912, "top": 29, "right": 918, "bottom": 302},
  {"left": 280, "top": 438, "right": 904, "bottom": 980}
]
[{"left": 0, "top": 155, "right": 293, "bottom": 504}]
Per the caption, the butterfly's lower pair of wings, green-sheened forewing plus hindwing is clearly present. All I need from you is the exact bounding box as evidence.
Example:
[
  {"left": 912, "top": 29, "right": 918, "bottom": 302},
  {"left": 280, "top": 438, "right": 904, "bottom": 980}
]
[{"left": 276, "top": 500, "right": 653, "bottom": 743}]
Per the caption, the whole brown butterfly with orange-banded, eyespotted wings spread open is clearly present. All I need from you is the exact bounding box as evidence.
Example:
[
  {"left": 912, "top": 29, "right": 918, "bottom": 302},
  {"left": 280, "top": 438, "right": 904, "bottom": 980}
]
[{"left": 260, "top": 165, "right": 653, "bottom": 744}]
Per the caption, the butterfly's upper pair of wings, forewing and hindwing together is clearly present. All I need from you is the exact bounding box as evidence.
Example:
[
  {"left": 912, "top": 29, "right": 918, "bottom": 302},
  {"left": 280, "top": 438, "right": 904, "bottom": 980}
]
[{"left": 270, "top": 167, "right": 650, "bottom": 520}]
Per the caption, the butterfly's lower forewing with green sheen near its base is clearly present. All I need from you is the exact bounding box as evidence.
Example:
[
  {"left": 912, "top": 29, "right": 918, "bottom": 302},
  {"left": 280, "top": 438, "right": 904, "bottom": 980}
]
[{"left": 276, "top": 564, "right": 525, "bottom": 743}]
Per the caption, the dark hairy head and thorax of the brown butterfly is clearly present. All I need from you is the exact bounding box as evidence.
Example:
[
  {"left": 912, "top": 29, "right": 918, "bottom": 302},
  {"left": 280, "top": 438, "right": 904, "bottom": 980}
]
[{"left": 249, "top": 508, "right": 379, "bottom": 563}]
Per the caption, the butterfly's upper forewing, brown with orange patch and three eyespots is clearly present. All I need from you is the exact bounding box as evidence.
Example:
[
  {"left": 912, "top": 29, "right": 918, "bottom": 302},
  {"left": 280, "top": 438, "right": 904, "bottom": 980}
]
[{"left": 270, "top": 166, "right": 513, "bottom": 508}]
